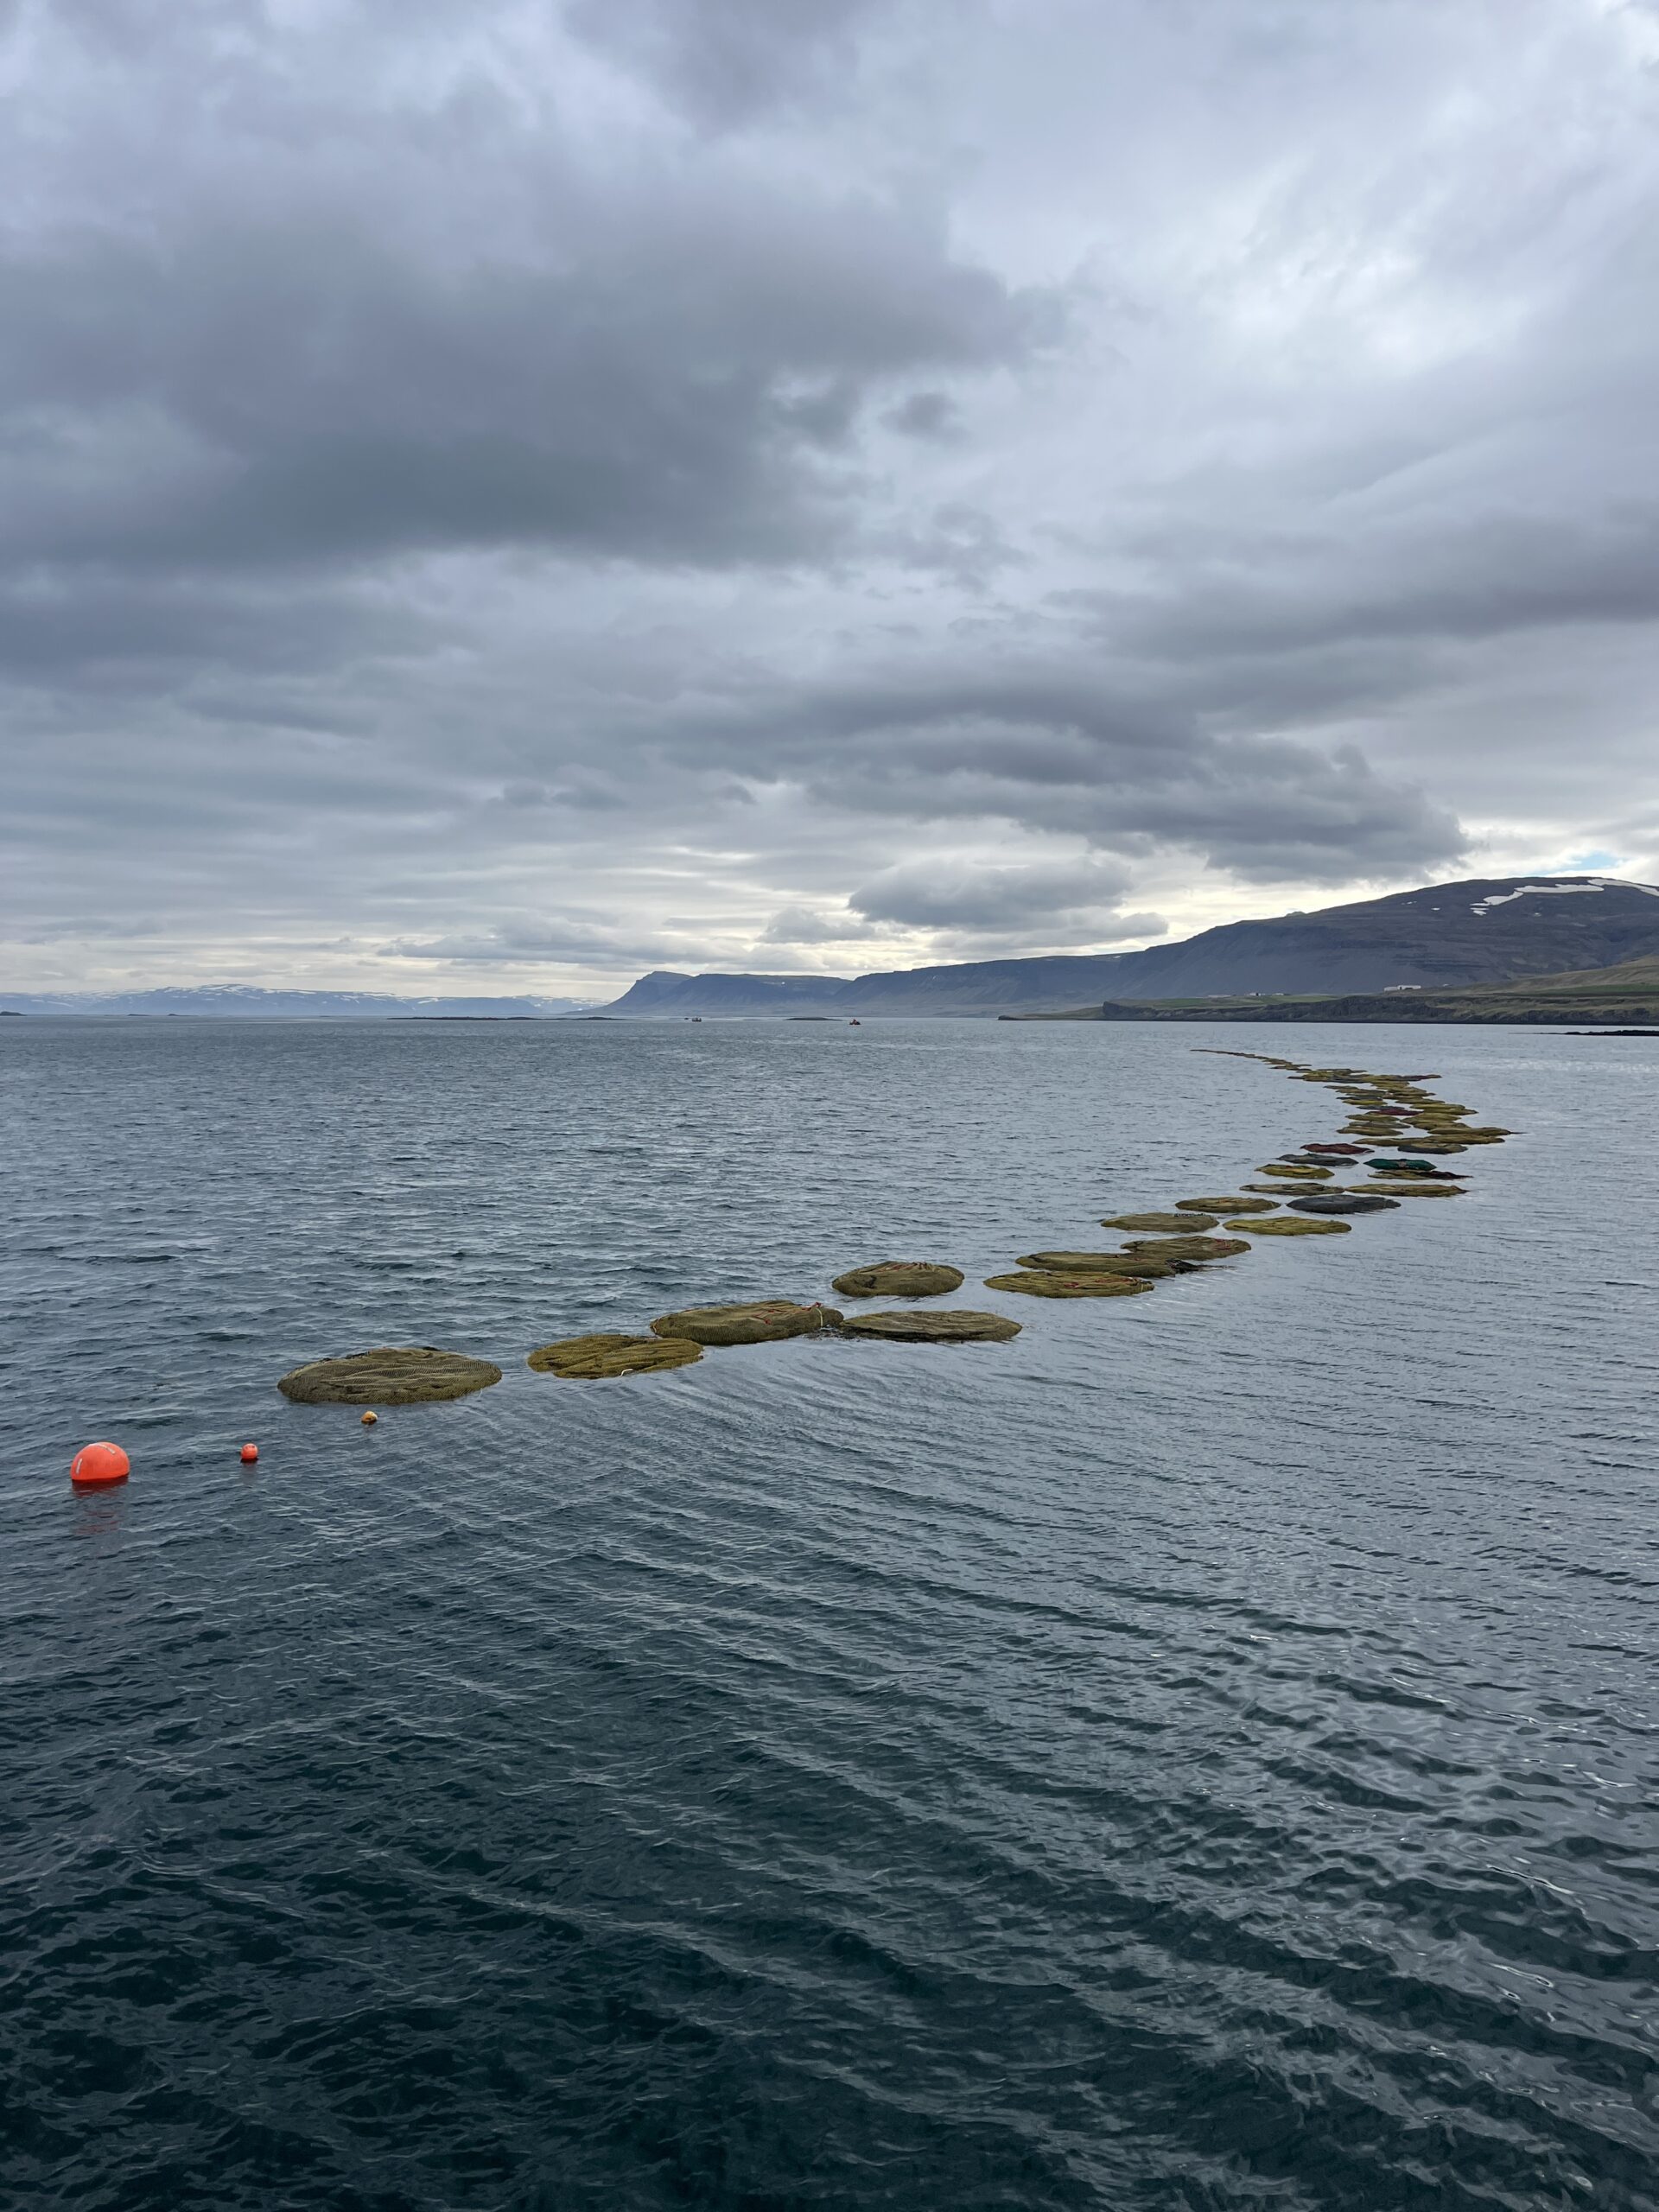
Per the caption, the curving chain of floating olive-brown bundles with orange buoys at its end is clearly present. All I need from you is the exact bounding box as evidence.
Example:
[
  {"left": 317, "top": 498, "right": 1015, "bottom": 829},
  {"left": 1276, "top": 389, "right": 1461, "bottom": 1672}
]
[{"left": 71, "top": 1046, "right": 1513, "bottom": 1489}]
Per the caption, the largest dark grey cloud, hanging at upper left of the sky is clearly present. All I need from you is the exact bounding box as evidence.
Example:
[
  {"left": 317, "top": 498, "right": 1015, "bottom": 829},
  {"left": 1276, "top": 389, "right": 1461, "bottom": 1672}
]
[{"left": 0, "top": 193, "right": 1038, "bottom": 566}]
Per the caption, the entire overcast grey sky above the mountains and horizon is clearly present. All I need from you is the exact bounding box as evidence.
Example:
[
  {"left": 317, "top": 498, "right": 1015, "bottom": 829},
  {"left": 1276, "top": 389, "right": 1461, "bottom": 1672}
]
[{"left": 0, "top": 0, "right": 1659, "bottom": 995}]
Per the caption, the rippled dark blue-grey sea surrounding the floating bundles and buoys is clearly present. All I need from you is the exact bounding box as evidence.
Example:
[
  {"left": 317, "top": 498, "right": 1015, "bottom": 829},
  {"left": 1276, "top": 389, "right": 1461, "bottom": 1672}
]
[{"left": 0, "top": 1020, "right": 1659, "bottom": 2212}]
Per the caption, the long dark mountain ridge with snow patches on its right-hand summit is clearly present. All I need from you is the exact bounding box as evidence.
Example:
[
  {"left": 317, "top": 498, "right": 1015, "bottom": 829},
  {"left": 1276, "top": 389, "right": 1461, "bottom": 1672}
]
[{"left": 604, "top": 876, "right": 1659, "bottom": 1018}]
